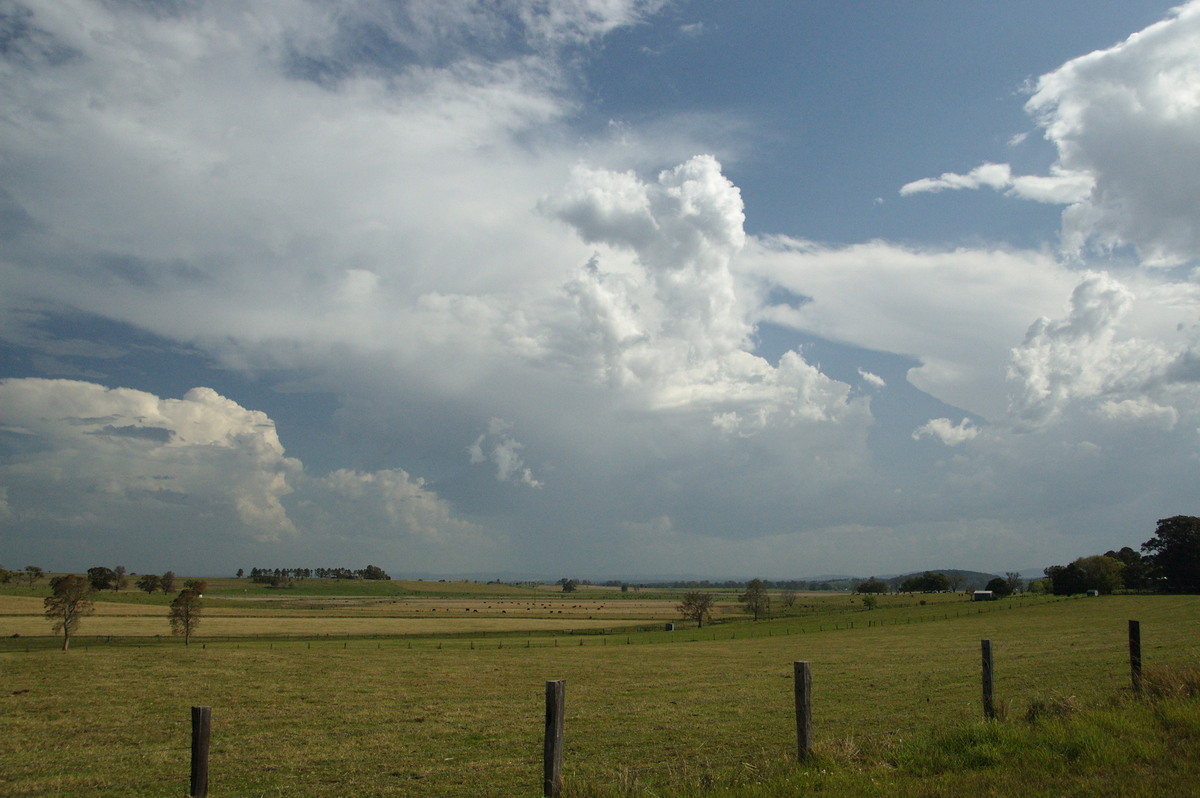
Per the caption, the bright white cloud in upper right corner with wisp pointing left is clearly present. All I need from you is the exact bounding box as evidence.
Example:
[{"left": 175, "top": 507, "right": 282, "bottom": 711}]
[{"left": 900, "top": 0, "right": 1200, "bottom": 266}]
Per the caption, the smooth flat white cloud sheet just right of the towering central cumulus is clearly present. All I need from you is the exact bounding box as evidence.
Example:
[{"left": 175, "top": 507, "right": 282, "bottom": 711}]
[{"left": 739, "top": 236, "right": 1076, "bottom": 419}]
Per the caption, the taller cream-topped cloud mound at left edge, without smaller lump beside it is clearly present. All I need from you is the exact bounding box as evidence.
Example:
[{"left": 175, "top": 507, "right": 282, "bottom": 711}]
[{"left": 0, "top": 379, "right": 300, "bottom": 541}]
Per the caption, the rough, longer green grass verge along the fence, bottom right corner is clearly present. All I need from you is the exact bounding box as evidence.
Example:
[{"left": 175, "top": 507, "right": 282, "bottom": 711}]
[{"left": 568, "top": 697, "right": 1200, "bottom": 798}]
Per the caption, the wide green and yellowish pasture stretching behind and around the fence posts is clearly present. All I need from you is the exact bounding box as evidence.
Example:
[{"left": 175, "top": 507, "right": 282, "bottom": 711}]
[{"left": 0, "top": 583, "right": 1200, "bottom": 797}]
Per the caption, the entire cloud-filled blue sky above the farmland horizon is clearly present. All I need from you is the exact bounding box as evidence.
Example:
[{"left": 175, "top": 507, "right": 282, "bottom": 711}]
[{"left": 0, "top": 0, "right": 1200, "bottom": 580}]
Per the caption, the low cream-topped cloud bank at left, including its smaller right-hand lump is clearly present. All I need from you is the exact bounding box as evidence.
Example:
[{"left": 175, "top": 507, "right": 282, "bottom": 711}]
[{"left": 0, "top": 379, "right": 482, "bottom": 560}]
